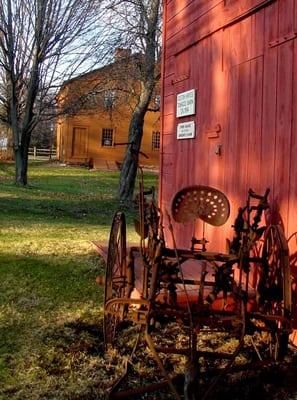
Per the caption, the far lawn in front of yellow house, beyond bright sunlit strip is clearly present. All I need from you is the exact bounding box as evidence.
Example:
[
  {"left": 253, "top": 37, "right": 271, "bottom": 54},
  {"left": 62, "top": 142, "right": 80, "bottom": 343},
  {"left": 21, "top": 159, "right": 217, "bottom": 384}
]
[{"left": 0, "top": 163, "right": 157, "bottom": 226}]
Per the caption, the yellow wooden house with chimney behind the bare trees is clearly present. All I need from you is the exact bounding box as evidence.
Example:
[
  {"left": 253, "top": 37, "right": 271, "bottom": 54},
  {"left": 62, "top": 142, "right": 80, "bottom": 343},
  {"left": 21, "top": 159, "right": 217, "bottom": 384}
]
[{"left": 56, "top": 49, "right": 160, "bottom": 168}]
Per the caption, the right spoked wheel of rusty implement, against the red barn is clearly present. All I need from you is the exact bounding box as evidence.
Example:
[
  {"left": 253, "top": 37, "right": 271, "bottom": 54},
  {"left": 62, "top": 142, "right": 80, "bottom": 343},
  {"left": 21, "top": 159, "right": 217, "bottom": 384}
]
[{"left": 258, "top": 225, "right": 291, "bottom": 360}]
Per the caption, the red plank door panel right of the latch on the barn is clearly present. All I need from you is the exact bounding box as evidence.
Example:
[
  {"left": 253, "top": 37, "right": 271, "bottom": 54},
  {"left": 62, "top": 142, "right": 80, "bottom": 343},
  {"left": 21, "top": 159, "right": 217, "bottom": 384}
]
[{"left": 225, "top": 57, "right": 265, "bottom": 206}]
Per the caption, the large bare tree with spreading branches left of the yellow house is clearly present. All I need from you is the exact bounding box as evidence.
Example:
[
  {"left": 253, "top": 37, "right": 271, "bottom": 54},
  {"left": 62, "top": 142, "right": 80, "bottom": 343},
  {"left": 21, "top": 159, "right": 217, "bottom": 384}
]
[{"left": 0, "top": 0, "right": 108, "bottom": 185}]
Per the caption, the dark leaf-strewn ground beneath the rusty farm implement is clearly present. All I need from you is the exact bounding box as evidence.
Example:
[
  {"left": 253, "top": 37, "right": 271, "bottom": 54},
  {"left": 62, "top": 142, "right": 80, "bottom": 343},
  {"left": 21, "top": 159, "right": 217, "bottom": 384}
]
[{"left": 106, "top": 324, "right": 297, "bottom": 400}]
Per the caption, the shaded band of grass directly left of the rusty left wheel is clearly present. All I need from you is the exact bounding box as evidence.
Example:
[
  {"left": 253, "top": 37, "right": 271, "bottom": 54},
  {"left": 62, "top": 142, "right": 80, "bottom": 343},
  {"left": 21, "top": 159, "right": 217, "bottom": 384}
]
[{"left": 0, "top": 251, "right": 104, "bottom": 309}]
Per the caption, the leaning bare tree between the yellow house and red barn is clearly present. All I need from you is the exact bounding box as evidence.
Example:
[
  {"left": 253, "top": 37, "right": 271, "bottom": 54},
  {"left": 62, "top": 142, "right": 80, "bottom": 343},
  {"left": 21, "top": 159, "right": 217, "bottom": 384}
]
[{"left": 109, "top": 0, "right": 161, "bottom": 203}]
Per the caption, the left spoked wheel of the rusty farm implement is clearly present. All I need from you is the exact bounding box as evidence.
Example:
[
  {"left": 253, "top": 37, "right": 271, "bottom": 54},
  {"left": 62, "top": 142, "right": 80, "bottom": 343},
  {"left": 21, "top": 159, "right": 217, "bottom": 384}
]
[{"left": 104, "top": 212, "right": 127, "bottom": 345}]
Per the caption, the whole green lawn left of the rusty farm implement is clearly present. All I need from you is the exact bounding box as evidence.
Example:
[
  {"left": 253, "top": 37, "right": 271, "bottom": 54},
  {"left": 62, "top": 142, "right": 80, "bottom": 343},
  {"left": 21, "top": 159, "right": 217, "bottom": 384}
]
[{"left": 0, "top": 162, "right": 156, "bottom": 400}]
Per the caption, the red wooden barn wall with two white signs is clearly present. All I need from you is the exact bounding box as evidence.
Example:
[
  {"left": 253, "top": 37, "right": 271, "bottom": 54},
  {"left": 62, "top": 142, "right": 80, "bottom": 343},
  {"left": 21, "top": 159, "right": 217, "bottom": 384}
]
[{"left": 160, "top": 0, "right": 297, "bottom": 336}]
